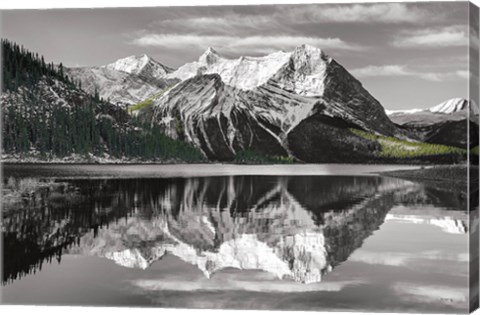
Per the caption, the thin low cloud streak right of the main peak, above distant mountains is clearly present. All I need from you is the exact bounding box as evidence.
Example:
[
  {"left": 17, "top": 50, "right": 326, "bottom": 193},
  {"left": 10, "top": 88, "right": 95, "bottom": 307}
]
[{"left": 350, "top": 65, "right": 468, "bottom": 82}]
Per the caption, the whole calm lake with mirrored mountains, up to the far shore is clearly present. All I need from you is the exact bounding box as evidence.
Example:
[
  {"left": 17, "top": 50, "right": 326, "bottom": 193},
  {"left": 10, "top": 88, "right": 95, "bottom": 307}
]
[{"left": 1, "top": 164, "right": 469, "bottom": 313}]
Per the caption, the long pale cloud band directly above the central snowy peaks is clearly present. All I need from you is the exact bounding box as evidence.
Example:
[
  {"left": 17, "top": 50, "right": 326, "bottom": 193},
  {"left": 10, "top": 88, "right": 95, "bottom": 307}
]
[{"left": 132, "top": 34, "right": 364, "bottom": 54}]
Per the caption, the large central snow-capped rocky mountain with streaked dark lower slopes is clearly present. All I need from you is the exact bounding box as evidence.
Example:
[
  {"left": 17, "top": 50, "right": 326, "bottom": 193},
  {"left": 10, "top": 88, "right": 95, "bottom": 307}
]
[{"left": 145, "top": 45, "right": 402, "bottom": 162}]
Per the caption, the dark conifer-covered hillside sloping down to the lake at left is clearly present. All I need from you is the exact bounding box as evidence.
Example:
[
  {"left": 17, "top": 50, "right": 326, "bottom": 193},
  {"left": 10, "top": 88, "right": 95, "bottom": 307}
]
[{"left": 2, "top": 40, "right": 203, "bottom": 161}]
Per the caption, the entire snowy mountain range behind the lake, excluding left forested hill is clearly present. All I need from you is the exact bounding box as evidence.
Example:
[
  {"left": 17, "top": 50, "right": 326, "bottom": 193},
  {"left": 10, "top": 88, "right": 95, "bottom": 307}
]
[{"left": 1, "top": 39, "right": 478, "bottom": 163}]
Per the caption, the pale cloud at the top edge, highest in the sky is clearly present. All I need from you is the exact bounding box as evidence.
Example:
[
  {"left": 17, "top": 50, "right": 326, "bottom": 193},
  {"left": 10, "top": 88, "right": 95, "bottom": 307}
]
[{"left": 284, "top": 3, "right": 439, "bottom": 23}]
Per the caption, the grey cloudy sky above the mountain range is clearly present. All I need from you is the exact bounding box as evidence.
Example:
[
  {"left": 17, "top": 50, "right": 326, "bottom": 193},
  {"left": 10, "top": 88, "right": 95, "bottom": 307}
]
[{"left": 1, "top": 2, "right": 472, "bottom": 110}]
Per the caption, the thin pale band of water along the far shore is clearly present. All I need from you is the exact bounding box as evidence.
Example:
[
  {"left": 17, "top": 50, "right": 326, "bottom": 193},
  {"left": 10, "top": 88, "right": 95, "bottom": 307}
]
[{"left": 3, "top": 163, "right": 420, "bottom": 178}]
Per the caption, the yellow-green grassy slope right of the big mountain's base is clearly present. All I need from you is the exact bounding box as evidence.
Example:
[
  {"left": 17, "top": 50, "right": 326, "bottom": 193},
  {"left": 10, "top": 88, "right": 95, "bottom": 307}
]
[{"left": 350, "top": 128, "right": 466, "bottom": 158}]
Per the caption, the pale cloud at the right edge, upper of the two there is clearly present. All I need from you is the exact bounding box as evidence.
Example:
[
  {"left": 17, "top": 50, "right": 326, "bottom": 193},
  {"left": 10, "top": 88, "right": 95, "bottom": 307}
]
[{"left": 393, "top": 25, "right": 469, "bottom": 48}]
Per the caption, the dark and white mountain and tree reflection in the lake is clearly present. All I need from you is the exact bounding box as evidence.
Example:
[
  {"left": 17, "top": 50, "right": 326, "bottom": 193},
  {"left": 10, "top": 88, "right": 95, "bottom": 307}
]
[{"left": 3, "top": 176, "right": 467, "bottom": 283}]
